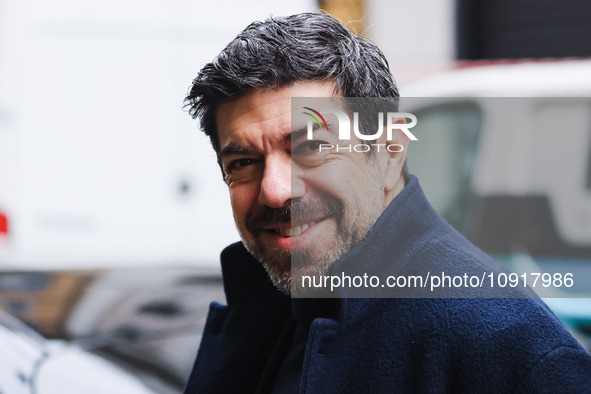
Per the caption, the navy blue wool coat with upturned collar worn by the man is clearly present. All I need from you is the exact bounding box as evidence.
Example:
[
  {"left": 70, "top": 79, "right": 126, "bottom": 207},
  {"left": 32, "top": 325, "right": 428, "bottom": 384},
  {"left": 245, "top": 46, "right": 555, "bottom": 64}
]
[{"left": 185, "top": 177, "right": 591, "bottom": 394}]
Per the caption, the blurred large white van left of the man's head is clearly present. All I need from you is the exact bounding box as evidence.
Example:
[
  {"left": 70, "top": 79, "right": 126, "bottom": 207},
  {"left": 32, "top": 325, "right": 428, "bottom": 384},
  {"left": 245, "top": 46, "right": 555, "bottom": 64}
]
[{"left": 0, "top": 0, "right": 315, "bottom": 269}]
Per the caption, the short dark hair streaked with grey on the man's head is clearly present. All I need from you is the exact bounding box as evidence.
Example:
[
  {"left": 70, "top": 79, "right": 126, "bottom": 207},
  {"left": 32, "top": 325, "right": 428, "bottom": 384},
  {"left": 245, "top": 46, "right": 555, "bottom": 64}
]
[{"left": 185, "top": 13, "right": 406, "bottom": 179}]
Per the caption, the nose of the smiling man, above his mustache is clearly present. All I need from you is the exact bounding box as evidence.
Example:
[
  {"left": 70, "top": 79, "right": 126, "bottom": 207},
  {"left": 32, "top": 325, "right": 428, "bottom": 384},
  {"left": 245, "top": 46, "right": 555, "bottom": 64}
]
[{"left": 259, "top": 156, "right": 300, "bottom": 208}]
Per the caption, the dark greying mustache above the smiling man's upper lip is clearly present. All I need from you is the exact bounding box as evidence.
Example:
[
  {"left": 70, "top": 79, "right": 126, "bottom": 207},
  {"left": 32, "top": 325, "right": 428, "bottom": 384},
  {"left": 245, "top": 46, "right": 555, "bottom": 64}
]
[{"left": 245, "top": 198, "right": 343, "bottom": 235}]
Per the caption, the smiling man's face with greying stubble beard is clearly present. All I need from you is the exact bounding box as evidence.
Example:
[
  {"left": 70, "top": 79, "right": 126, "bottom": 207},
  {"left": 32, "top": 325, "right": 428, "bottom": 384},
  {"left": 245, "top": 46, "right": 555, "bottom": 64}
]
[{"left": 216, "top": 82, "right": 403, "bottom": 293}]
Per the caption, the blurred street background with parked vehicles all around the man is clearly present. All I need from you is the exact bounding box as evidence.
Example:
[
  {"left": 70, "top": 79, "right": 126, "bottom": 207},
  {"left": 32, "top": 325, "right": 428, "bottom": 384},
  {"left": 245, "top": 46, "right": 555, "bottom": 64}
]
[{"left": 0, "top": 0, "right": 591, "bottom": 394}]
